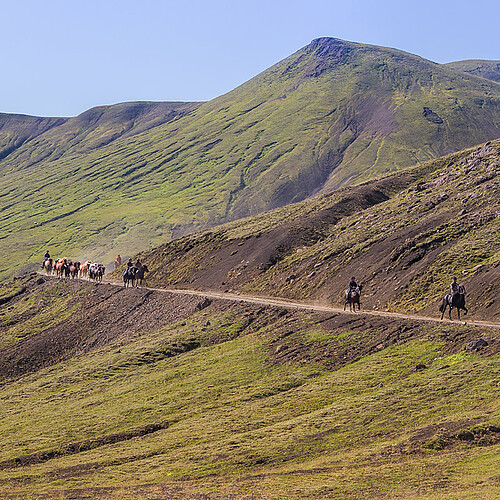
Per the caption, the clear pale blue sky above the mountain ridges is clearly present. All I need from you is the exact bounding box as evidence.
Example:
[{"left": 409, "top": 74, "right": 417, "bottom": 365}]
[{"left": 0, "top": 0, "right": 500, "bottom": 116}]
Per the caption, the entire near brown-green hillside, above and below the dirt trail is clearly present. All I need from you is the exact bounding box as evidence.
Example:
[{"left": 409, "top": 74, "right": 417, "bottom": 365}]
[{"left": 0, "top": 133, "right": 500, "bottom": 500}]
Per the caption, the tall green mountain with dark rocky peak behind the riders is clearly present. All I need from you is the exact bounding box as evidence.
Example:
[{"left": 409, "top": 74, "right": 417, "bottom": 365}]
[{"left": 0, "top": 39, "right": 500, "bottom": 280}]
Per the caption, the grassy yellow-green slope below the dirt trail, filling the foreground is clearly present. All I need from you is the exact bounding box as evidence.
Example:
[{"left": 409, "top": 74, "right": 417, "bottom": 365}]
[{"left": 0, "top": 278, "right": 500, "bottom": 499}]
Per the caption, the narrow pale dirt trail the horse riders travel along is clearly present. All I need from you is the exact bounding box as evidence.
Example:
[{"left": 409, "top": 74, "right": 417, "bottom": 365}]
[{"left": 103, "top": 279, "right": 500, "bottom": 329}]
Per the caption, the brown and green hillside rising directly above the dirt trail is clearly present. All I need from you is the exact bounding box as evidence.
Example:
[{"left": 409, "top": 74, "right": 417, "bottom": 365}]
[{"left": 141, "top": 141, "right": 500, "bottom": 320}]
